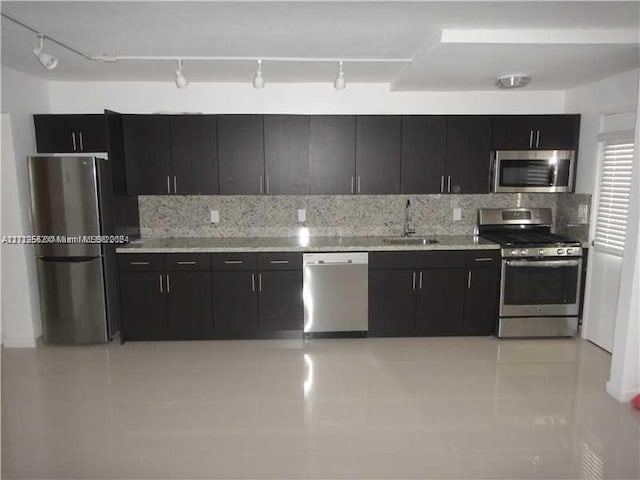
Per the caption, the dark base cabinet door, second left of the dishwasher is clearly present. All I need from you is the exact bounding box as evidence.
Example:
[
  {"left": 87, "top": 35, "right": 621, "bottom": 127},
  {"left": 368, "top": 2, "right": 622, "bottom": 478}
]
[{"left": 213, "top": 271, "right": 258, "bottom": 338}]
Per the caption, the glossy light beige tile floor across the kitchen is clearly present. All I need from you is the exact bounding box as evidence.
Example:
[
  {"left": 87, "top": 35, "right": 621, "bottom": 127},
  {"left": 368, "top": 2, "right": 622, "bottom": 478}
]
[{"left": 2, "top": 338, "right": 640, "bottom": 480}]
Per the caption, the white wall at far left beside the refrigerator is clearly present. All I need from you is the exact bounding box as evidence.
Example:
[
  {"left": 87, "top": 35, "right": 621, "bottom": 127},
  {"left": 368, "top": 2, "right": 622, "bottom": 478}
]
[{"left": 0, "top": 67, "right": 49, "bottom": 347}]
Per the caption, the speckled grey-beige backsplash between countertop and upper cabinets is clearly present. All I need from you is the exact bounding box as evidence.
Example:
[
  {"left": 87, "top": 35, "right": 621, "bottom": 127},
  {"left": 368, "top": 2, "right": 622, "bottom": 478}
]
[{"left": 138, "top": 189, "right": 591, "bottom": 239}]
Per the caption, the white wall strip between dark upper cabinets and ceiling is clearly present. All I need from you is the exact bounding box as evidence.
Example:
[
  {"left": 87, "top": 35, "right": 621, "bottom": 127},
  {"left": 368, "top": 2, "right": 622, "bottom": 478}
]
[{"left": 49, "top": 82, "right": 565, "bottom": 114}]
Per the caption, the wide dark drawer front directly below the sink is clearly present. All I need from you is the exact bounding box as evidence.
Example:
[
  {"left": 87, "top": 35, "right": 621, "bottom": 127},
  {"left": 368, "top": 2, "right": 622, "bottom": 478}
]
[{"left": 369, "top": 250, "right": 466, "bottom": 269}]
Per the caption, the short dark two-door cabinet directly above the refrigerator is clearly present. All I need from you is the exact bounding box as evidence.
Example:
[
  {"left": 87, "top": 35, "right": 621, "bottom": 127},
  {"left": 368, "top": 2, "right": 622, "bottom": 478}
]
[{"left": 33, "top": 114, "right": 107, "bottom": 153}]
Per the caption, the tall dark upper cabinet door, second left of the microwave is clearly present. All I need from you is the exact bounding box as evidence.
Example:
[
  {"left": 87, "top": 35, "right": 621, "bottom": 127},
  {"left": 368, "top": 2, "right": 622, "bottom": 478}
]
[{"left": 400, "top": 115, "right": 447, "bottom": 193}]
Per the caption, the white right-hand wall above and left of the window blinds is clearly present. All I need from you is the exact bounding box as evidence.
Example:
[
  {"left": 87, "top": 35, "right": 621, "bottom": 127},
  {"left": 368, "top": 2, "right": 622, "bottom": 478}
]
[{"left": 564, "top": 70, "right": 640, "bottom": 193}]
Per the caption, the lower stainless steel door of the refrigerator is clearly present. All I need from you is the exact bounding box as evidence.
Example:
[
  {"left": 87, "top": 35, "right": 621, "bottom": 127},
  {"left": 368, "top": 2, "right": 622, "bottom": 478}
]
[{"left": 37, "top": 258, "right": 107, "bottom": 343}]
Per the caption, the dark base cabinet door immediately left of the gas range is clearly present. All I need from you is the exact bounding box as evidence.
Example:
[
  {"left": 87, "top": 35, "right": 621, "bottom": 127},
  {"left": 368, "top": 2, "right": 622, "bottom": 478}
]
[{"left": 464, "top": 268, "right": 498, "bottom": 335}]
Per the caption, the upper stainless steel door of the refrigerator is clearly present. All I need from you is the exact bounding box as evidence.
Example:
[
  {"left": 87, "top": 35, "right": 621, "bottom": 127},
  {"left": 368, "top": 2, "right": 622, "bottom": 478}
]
[{"left": 29, "top": 156, "right": 101, "bottom": 257}]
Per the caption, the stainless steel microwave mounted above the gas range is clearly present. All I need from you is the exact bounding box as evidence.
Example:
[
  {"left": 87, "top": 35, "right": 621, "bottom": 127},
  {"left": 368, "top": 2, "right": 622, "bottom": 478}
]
[{"left": 492, "top": 150, "right": 575, "bottom": 193}]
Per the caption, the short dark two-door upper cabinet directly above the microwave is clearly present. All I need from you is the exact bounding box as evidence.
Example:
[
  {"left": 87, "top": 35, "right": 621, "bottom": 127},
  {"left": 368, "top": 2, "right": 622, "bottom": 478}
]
[{"left": 492, "top": 115, "right": 580, "bottom": 150}]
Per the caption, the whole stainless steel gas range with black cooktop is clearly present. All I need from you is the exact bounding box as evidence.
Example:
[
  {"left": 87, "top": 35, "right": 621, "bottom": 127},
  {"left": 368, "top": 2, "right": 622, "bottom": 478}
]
[{"left": 478, "top": 208, "right": 582, "bottom": 337}]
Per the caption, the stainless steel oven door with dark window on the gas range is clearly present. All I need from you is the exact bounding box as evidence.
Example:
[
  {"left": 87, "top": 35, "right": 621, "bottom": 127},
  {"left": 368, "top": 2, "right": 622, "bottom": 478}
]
[{"left": 500, "top": 258, "right": 582, "bottom": 317}]
